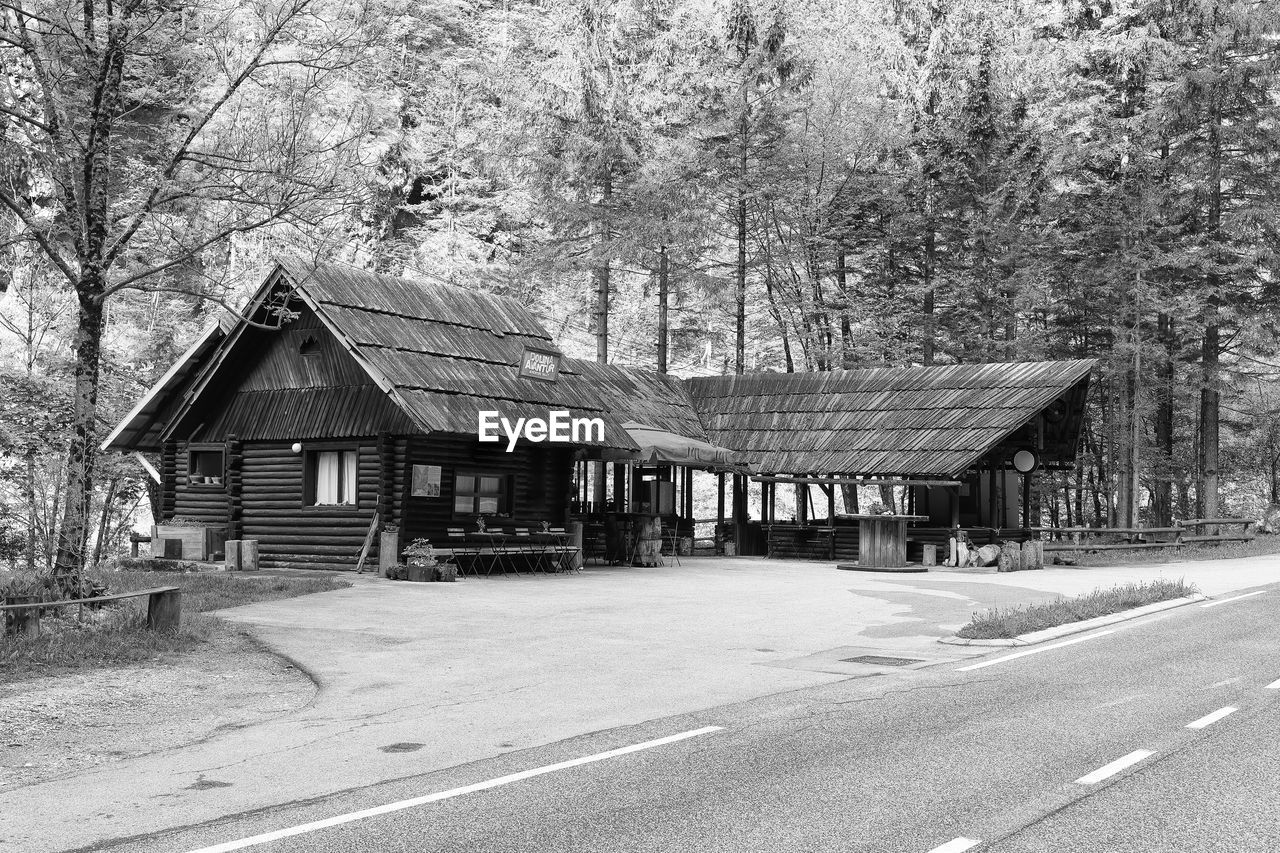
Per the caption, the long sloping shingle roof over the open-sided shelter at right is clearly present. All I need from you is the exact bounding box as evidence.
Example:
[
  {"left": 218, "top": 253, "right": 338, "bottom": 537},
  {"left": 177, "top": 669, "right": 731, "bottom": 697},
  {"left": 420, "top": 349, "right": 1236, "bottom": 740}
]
[{"left": 685, "top": 360, "right": 1094, "bottom": 476}]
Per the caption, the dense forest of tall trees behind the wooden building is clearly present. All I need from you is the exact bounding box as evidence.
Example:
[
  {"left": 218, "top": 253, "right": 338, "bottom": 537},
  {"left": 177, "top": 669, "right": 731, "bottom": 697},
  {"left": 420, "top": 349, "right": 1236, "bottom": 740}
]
[{"left": 0, "top": 0, "right": 1280, "bottom": 571}]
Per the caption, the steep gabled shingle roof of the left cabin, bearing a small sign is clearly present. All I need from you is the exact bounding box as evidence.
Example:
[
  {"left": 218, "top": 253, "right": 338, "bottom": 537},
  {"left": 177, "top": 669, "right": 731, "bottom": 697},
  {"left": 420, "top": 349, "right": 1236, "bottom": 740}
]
[{"left": 102, "top": 260, "right": 640, "bottom": 450}]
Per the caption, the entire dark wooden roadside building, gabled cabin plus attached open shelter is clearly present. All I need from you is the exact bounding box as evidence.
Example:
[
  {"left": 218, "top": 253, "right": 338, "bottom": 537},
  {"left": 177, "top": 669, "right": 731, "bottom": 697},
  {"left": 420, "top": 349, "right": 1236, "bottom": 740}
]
[{"left": 102, "top": 261, "right": 1093, "bottom": 569}]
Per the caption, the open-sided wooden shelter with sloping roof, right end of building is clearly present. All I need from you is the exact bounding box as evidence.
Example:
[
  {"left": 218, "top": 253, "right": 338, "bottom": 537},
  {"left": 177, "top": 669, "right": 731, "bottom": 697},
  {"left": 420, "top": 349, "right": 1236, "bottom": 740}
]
[{"left": 686, "top": 360, "right": 1096, "bottom": 558}]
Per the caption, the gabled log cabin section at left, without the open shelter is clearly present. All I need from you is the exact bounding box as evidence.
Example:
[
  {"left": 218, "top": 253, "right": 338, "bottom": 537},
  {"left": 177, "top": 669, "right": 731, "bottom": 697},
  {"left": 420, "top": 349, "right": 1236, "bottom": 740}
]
[{"left": 102, "top": 261, "right": 637, "bottom": 569}]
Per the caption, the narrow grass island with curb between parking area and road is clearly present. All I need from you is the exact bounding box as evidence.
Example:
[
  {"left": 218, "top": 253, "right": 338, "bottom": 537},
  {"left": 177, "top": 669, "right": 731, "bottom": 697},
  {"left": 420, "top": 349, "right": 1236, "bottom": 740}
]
[{"left": 956, "top": 578, "right": 1197, "bottom": 639}]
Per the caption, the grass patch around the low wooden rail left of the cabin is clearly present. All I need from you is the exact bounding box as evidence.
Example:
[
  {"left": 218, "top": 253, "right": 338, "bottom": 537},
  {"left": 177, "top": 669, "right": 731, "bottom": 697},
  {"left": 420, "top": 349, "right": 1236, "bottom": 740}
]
[{"left": 0, "top": 571, "right": 351, "bottom": 683}]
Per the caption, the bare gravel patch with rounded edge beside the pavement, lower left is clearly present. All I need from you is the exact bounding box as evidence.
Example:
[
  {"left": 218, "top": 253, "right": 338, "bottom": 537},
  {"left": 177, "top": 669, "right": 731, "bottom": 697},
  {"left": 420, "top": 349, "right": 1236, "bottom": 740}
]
[{"left": 0, "top": 629, "right": 316, "bottom": 792}]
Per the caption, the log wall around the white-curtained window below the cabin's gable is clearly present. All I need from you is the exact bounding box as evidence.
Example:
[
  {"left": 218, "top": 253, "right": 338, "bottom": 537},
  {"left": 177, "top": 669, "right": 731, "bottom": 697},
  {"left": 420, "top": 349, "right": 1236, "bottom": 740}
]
[{"left": 241, "top": 438, "right": 381, "bottom": 569}]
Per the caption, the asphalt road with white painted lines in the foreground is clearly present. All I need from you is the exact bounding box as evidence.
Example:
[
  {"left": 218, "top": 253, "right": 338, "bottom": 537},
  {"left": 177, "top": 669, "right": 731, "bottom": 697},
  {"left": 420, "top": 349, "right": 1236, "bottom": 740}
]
[{"left": 85, "top": 588, "right": 1280, "bottom": 853}]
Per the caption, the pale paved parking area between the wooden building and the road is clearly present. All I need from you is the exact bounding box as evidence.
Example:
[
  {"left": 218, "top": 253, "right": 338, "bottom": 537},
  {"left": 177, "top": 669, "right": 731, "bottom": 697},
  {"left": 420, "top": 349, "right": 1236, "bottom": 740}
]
[{"left": 0, "top": 548, "right": 1280, "bottom": 853}]
